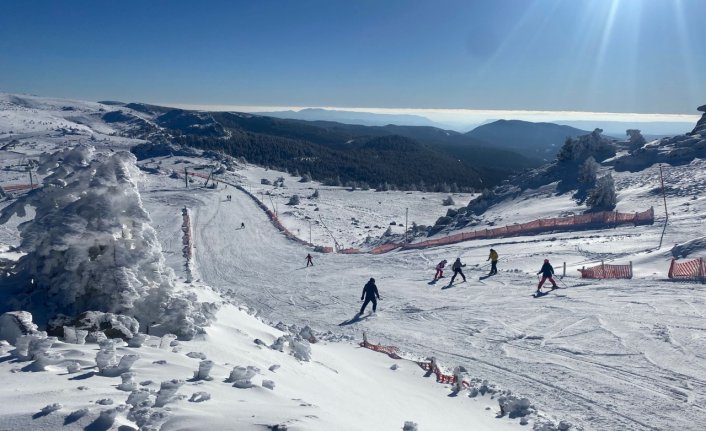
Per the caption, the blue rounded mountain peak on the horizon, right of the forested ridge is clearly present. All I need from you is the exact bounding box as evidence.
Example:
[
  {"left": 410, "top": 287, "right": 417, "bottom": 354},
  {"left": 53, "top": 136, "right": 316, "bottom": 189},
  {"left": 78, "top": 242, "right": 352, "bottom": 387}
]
[{"left": 466, "top": 120, "right": 589, "bottom": 160}]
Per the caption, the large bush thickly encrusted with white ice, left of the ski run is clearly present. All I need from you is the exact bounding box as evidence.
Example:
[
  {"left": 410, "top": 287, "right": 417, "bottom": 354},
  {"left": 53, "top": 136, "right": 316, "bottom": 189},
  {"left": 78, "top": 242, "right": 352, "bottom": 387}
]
[{"left": 0, "top": 145, "right": 215, "bottom": 339}]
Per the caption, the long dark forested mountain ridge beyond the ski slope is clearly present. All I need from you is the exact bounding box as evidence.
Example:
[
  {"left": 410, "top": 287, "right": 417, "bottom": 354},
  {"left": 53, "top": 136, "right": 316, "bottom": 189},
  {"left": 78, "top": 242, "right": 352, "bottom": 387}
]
[{"left": 140, "top": 109, "right": 537, "bottom": 191}]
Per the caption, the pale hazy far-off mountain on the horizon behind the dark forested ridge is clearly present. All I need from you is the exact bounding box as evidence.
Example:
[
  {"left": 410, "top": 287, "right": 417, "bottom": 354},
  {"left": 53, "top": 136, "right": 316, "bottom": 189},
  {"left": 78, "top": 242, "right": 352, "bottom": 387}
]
[{"left": 253, "top": 108, "right": 444, "bottom": 127}]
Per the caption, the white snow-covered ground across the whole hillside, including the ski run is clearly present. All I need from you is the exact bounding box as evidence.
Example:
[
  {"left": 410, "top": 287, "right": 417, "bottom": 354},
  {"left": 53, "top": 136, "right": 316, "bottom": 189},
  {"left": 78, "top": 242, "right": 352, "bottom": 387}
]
[{"left": 0, "top": 95, "right": 706, "bottom": 430}]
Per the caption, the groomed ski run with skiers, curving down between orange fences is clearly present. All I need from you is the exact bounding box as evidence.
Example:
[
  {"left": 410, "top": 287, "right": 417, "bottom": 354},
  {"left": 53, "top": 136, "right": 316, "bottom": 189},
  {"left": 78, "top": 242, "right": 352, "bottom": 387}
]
[{"left": 173, "top": 188, "right": 706, "bottom": 431}]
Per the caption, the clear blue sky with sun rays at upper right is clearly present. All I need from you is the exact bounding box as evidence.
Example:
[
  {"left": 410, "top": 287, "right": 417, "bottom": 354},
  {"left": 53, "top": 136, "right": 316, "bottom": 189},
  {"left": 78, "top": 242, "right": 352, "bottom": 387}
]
[{"left": 0, "top": 0, "right": 706, "bottom": 114}]
